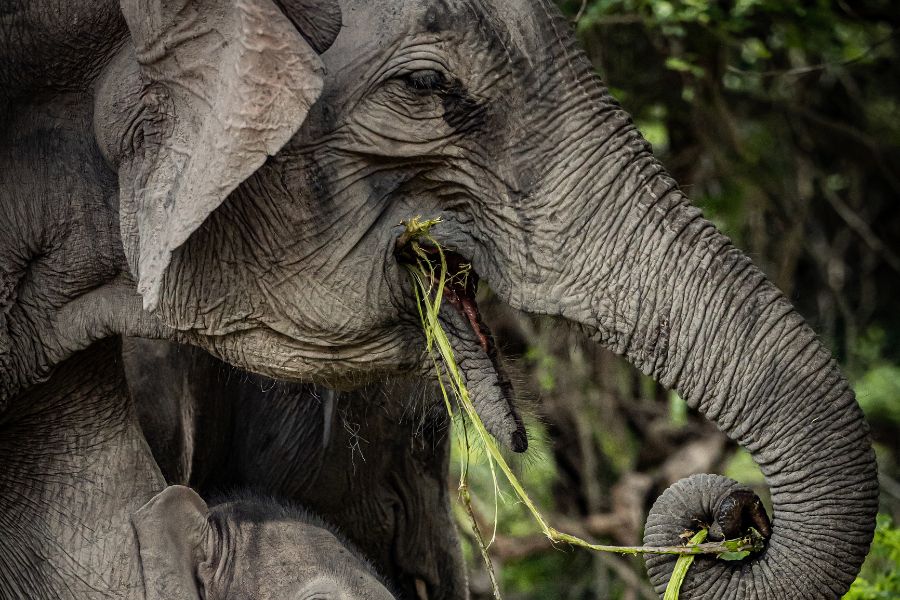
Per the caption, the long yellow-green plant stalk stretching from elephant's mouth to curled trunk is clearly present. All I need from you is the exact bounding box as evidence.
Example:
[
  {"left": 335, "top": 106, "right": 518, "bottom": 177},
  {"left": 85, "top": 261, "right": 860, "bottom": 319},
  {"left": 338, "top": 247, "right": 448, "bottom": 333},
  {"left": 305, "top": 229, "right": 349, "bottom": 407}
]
[{"left": 404, "top": 218, "right": 763, "bottom": 556}]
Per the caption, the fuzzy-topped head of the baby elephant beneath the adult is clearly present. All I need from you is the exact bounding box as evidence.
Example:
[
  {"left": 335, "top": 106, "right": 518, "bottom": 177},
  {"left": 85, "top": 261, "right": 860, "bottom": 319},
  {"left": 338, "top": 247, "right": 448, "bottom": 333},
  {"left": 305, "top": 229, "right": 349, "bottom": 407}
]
[{"left": 132, "top": 485, "right": 394, "bottom": 600}]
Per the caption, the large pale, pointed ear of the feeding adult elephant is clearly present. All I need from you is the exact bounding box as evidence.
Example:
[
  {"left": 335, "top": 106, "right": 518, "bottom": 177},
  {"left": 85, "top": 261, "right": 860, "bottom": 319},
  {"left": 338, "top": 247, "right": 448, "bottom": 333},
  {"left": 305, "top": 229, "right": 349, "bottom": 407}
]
[{"left": 119, "top": 0, "right": 340, "bottom": 310}]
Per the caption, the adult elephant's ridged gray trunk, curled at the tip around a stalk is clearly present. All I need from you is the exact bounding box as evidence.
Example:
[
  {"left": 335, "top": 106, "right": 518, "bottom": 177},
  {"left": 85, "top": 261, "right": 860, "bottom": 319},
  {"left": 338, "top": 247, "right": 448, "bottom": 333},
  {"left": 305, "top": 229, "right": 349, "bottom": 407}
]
[{"left": 501, "top": 113, "right": 877, "bottom": 600}]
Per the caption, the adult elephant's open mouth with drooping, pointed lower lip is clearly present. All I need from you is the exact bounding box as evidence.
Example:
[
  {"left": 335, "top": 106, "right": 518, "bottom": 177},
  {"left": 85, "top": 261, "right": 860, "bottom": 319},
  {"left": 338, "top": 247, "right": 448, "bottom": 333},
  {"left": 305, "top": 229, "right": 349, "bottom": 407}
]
[{"left": 397, "top": 244, "right": 528, "bottom": 452}]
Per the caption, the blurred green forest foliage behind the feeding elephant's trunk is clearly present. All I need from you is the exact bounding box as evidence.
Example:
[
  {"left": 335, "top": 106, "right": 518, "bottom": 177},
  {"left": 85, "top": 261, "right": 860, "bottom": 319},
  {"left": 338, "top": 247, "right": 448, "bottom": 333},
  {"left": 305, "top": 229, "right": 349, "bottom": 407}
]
[{"left": 461, "top": 0, "right": 900, "bottom": 600}]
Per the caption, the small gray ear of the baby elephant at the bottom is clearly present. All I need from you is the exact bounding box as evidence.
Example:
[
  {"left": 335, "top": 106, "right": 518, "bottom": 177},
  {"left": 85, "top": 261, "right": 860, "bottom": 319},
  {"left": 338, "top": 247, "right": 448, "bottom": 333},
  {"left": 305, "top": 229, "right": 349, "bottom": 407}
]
[{"left": 131, "top": 485, "right": 210, "bottom": 600}]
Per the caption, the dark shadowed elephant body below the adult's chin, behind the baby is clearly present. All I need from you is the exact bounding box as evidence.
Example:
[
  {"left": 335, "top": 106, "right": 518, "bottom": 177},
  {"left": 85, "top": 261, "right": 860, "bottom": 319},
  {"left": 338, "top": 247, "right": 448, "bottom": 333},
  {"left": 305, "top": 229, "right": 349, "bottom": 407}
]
[{"left": 123, "top": 338, "right": 466, "bottom": 600}]
